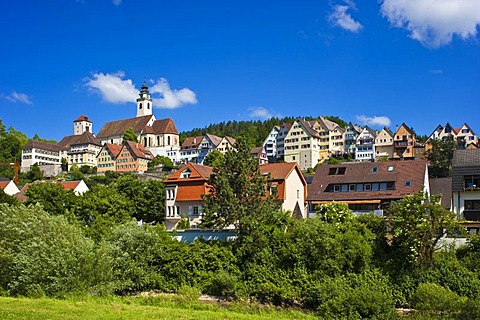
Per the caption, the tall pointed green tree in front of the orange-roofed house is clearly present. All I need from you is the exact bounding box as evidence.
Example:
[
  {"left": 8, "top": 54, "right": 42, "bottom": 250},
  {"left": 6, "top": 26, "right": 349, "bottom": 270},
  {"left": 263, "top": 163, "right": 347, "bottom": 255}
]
[{"left": 201, "top": 139, "right": 274, "bottom": 229}]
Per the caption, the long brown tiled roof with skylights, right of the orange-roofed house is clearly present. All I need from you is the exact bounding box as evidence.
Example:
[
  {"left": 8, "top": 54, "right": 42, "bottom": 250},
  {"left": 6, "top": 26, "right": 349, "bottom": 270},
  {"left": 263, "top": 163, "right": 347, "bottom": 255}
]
[{"left": 307, "top": 159, "right": 427, "bottom": 201}]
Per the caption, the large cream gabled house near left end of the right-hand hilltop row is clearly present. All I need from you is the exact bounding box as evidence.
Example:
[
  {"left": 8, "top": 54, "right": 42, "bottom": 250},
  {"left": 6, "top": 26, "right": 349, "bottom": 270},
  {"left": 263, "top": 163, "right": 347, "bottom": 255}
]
[{"left": 283, "top": 119, "right": 320, "bottom": 170}]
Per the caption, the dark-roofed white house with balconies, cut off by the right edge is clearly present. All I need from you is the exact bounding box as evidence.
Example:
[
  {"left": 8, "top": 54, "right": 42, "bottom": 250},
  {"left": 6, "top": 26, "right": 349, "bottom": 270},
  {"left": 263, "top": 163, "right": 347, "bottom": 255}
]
[{"left": 452, "top": 149, "right": 480, "bottom": 233}]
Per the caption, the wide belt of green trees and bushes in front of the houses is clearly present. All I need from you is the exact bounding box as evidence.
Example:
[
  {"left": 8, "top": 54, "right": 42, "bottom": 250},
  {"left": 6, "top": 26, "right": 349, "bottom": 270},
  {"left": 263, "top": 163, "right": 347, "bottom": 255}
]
[{"left": 0, "top": 139, "right": 480, "bottom": 319}]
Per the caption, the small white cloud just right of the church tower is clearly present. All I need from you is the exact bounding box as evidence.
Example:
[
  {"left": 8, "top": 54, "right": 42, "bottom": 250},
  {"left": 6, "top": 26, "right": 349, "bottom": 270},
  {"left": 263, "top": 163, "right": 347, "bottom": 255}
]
[{"left": 150, "top": 78, "right": 198, "bottom": 109}]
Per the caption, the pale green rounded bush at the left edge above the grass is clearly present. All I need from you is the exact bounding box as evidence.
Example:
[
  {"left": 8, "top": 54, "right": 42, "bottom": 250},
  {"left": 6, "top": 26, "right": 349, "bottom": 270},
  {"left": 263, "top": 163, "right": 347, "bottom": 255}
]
[{"left": 0, "top": 204, "right": 108, "bottom": 297}]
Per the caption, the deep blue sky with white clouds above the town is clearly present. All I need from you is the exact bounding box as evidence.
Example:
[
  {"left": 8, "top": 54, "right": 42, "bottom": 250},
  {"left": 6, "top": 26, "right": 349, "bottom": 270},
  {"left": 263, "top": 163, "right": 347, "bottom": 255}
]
[{"left": 0, "top": 0, "right": 480, "bottom": 140}]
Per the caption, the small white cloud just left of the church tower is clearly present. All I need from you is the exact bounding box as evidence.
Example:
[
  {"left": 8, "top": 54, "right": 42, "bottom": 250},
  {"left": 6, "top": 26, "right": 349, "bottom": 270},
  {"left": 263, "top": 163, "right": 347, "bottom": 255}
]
[{"left": 85, "top": 71, "right": 139, "bottom": 103}]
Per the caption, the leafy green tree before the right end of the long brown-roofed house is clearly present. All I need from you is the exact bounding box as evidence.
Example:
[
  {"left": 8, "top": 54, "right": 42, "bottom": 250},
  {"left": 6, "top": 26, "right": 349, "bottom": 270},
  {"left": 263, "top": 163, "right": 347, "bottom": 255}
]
[{"left": 386, "top": 192, "right": 462, "bottom": 266}]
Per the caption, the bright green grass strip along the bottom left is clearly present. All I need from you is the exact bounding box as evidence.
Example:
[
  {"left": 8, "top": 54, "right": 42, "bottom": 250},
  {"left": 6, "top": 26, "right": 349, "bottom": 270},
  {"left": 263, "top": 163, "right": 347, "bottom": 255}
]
[{"left": 0, "top": 297, "right": 318, "bottom": 320}]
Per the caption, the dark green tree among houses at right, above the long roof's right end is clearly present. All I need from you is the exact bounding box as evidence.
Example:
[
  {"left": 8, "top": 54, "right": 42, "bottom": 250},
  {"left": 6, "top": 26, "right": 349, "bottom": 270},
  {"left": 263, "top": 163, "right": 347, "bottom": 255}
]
[{"left": 425, "top": 136, "right": 458, "bottom": 177}]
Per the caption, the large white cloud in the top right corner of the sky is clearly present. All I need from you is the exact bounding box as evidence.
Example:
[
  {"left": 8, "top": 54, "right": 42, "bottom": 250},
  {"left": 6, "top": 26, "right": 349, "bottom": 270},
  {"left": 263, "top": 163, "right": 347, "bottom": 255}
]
[{"left": 380, "top": 0, "right": 480, "bottom": 48}]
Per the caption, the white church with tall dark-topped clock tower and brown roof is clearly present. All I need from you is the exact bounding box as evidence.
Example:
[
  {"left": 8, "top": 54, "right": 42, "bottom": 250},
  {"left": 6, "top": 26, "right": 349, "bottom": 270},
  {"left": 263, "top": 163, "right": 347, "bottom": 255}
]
[{"left": 97, "top": 83, "right": 180, "bottom": 161}]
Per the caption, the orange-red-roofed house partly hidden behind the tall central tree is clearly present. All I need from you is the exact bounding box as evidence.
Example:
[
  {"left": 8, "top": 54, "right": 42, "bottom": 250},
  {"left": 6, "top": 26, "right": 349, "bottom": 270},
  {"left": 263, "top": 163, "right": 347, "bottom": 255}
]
[{"left": 165, "top": 163, "right": 307, "bottom": 230}]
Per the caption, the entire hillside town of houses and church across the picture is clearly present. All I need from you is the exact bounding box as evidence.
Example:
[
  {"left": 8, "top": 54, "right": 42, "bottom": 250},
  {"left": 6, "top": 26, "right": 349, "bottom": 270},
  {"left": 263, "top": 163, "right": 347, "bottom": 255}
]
[{"left": 1, "top": 83, "right": 480, "bottom": 233}]
